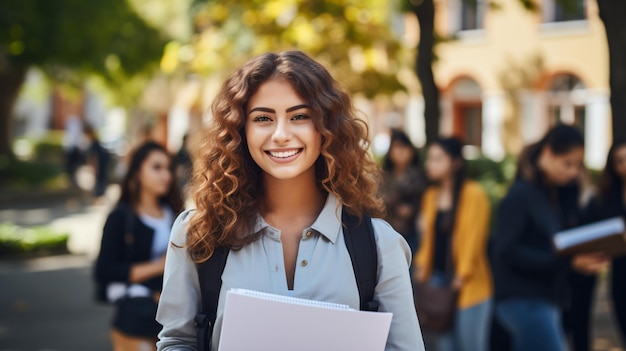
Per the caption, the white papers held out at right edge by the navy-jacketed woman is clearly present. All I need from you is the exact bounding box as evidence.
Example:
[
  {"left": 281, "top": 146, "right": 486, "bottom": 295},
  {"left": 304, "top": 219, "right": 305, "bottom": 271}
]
[{"left": 554, "top": 217, "right": 625, "bottom": 250}]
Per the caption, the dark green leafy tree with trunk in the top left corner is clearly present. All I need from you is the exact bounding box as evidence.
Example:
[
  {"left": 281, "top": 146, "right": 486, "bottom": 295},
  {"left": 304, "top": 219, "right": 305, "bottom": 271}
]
[{"left": 0, "top": 0, "right": 165, "bottom": 155}]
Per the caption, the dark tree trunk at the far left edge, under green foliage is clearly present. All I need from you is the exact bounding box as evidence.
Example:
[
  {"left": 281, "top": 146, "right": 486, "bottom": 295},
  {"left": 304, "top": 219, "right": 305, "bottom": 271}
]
[{"left": 0, "top": 65, "right": 26, "bottom": 157}]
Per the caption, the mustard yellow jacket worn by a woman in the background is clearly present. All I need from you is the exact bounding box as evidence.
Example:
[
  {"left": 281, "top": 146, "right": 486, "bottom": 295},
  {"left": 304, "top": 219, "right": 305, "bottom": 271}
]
[{"left": 415, "top": 181, "right": 493, "bottom": 308}]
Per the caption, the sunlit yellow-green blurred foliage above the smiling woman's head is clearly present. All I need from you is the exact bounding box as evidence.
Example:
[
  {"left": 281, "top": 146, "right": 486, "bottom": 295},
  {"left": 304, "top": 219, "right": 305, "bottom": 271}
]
[{"left": 164, "top": 0, "right": 404, "bottom": 97}]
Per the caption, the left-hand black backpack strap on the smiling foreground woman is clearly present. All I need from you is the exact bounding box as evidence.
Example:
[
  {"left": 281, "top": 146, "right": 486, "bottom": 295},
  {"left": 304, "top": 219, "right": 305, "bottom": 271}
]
[{"left": 195, "top": 246, "right": 229, "bottom": 351}]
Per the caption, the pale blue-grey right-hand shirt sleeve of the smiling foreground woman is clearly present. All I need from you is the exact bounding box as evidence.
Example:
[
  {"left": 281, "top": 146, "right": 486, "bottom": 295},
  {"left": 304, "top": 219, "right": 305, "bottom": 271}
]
[{"left": 372, "top": 219, "right": 424, "bottom": 351}]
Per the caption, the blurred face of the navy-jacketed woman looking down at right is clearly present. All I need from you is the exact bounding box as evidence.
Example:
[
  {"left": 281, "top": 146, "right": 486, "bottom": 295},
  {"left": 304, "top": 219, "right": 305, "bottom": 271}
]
[{"left": 539, "top": 147, "right": 585, "bottom": 186}]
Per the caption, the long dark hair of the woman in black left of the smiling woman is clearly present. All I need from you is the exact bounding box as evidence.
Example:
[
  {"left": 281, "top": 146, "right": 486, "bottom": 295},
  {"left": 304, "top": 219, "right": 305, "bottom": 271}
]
[{"left": 119, "top": 141, "right": 183, "bottom": 215}]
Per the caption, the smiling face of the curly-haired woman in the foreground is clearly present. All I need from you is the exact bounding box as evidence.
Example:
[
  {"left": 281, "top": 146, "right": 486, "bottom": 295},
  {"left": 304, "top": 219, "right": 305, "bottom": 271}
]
[{"left": 245, "top": 77, "right": 322, "bottom": 180}]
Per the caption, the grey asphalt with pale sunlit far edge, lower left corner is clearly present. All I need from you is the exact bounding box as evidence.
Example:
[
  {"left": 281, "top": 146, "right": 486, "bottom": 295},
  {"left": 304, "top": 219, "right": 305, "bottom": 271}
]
[{"left": 0, "top": 256, "right": 111, "bottom": 351}]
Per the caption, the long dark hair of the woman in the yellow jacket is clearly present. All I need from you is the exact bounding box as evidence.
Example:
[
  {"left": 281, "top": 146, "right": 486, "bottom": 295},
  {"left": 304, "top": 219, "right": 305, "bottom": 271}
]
[{"left": 430, "top": 137, "right": 467, "bottom": 234}]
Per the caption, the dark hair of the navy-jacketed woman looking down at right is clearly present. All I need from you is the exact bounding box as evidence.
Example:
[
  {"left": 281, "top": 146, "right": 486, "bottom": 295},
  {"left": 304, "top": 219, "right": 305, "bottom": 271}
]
[{"left": 515, "top": 124, "right": 585, "bottom": 184}]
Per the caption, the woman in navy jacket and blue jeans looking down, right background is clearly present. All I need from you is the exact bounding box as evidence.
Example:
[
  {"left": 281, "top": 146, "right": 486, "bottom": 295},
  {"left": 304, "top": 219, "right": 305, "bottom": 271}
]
[{"left": 493, "top": 125, "right": 597, "bottom": 351}]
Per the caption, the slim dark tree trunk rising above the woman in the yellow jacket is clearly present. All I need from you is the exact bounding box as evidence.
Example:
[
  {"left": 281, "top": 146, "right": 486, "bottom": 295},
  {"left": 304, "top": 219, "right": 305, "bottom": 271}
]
[{"left": 412, "top": 0, "right": 441, "bottom": 143}]
